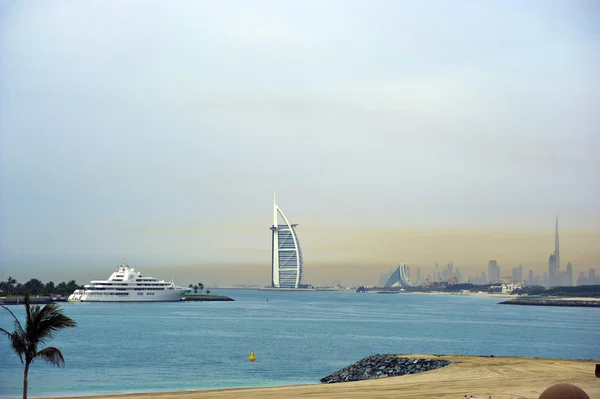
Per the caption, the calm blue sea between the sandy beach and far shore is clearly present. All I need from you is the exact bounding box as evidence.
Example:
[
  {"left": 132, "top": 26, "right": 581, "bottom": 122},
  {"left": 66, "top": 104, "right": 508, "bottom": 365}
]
[{"left": 0, "top": 290, "right": 600, "bottom": 397}]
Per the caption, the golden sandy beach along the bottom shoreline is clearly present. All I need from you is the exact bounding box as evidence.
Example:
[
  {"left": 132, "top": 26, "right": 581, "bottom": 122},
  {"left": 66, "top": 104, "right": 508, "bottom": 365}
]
[{"left": 45, "top": 355, "right": 600, "bottom": 399}]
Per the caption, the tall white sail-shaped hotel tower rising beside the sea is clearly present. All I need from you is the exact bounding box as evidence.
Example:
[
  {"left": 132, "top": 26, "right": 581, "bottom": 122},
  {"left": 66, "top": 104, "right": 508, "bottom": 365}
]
[{"left": 271, "top": 195, "right": 303, "bottom": 288}]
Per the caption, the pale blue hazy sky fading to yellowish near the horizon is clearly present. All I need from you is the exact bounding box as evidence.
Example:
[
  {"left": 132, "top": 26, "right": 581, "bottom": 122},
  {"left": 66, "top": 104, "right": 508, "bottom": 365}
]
[{"left": 0, "top": 0, "right": 600, "bottom": 284}]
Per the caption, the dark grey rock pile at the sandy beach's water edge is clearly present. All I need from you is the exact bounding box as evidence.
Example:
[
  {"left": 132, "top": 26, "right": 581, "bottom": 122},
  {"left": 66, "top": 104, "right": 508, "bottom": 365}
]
[{"left": 321, "top": 355, "right": 452, "bottom": 384}]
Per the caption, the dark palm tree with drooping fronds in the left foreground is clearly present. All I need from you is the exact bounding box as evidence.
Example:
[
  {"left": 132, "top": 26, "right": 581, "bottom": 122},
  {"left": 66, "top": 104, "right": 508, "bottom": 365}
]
[{"left": 0, "top": 291, "right": 77, "bottom": 399}]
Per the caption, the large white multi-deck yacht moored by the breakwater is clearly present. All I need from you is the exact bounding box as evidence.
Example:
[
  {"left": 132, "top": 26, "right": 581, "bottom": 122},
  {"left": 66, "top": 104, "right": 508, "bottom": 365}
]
[{"left": 67, "top": 259, "right": 190, "bottom": 302}]
